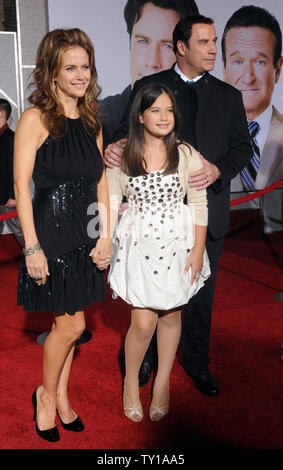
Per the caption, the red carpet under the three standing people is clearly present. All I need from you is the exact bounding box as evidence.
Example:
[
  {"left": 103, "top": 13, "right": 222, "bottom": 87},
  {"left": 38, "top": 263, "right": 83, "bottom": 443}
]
[{"left": 0, "top": 222, "right": 283, "bottom": 449}]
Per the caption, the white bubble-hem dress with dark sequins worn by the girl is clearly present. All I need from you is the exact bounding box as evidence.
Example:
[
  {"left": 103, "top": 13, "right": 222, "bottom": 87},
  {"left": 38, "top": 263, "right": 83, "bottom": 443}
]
[{"left": 108, "top": 145, "right": 210, "bottom": 310}]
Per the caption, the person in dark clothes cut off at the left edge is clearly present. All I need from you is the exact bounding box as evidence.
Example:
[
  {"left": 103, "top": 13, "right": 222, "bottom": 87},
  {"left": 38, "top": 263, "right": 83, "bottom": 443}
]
[{"left": 0, "top": 98, "right": 24, "bottom": 246}]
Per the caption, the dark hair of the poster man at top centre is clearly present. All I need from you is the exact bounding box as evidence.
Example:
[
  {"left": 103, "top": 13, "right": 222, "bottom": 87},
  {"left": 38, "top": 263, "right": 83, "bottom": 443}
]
[{"left": 124, "top": 0, "right": 199, "bottom": 36}]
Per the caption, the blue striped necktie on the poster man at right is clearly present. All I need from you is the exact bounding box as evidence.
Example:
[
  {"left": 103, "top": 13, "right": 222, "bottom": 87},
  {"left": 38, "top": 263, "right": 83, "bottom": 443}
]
[{"left": 241, "top": 121, "right": 260, "bottom": 191}]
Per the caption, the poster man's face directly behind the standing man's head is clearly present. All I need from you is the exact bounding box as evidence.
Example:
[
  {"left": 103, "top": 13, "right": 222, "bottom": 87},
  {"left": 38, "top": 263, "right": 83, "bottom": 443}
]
[{"left": 130, "top": 3, "right": 180, "bottom": 84}]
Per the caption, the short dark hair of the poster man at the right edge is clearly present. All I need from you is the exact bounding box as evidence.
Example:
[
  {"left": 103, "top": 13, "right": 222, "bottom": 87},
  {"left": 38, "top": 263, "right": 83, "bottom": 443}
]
[{"left": 221, "top": 5, "right": 282, "bottom": 67}]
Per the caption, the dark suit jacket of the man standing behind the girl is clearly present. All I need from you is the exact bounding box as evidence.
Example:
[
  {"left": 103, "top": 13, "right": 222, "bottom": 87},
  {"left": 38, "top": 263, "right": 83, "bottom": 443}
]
[{"left": 112, "top": 66, "right": 252, "bottom": 239}]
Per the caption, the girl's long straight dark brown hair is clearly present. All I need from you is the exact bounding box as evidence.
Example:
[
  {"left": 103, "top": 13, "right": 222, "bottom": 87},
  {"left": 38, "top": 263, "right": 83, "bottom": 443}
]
[{"left": 121, "top": 83, "right": 180, "bottom": 176}]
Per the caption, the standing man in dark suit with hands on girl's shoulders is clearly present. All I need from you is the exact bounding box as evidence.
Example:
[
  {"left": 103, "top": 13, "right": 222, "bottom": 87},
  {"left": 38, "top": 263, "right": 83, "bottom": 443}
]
[{"left": 105, "top": 15, "right": 252, "bottom": 396}]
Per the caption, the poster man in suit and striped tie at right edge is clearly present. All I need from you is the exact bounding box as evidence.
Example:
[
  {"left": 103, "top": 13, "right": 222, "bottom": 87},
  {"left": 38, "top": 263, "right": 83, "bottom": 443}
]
[{"left": 222, "top": 6, "right": 283, "bottom": 233}]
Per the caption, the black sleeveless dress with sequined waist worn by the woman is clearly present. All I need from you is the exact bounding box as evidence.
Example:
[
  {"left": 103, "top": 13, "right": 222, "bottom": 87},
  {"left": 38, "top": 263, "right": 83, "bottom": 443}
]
[{"left": 18, "top": 118, "right": 105, "bottom": 315}]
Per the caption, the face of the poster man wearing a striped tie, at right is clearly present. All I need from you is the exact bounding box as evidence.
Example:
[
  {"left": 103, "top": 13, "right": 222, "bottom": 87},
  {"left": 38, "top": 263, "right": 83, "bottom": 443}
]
[{"left": 223, "top": 26, "right": 282, "bottom": 120}]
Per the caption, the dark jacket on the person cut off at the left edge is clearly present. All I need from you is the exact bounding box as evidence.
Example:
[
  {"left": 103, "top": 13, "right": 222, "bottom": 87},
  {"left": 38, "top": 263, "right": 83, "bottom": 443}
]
[{"left": 0, "top": 127, "right": 15, "bottom": 205}]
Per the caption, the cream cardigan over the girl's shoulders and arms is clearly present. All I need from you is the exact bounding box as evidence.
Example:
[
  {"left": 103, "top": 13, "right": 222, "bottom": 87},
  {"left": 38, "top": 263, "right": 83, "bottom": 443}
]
[{"left": 106, "top": 144, "right": 208, "bottom": 226}]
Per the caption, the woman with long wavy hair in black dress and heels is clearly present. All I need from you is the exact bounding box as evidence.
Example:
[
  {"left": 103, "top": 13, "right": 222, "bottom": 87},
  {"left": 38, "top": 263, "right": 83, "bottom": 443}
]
[{"left": 14, "top": 29, "right": 112, "bottom": 441}]
